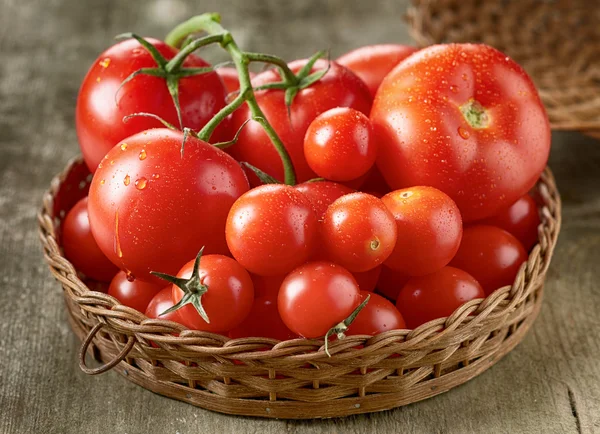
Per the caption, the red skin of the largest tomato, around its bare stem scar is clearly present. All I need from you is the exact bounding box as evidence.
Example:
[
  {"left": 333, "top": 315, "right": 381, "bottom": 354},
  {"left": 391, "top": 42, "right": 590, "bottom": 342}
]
[{"left": 371, "top": 44, "right": 550, "bottom": 222}]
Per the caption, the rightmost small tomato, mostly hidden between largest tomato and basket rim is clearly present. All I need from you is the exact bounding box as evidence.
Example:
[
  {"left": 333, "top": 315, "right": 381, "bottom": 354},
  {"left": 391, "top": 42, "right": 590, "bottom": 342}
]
[{"left": 478, "top": 194, "right": 540, "bottom": 251}]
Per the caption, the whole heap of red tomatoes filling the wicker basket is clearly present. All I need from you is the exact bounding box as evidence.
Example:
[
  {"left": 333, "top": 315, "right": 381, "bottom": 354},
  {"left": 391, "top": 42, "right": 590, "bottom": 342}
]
[{"left": 62, "top": 22, "right": 550, "bottom": 346}]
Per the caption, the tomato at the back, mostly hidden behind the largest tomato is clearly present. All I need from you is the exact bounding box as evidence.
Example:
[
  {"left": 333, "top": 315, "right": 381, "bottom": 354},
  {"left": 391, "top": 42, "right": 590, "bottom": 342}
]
[{"left": 336, "top": 44, "right": 418, "bottom": 97}]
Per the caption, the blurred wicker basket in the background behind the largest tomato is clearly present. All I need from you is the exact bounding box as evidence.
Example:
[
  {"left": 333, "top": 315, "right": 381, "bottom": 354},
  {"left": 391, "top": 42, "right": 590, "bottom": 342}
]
[{"left": 407, "top": 0, "right": 600, "bottom": 138}]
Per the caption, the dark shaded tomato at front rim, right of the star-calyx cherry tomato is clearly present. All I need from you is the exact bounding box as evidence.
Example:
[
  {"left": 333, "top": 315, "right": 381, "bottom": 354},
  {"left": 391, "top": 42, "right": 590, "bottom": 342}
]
[{"left": 229, "top": 294, "right": 298, "bottom": 341}]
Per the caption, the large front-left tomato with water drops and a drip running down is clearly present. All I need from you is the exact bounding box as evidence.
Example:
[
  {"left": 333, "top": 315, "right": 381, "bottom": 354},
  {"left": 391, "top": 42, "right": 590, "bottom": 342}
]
[{"left": 88, "top": 129, "right": 249, "bottom": 283}]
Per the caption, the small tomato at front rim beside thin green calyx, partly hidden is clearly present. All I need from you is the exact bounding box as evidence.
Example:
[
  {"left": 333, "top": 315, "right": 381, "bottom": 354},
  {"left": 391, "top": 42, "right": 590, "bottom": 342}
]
[{"left": 346, "top": 291, "right": 406, "bottom": 336}]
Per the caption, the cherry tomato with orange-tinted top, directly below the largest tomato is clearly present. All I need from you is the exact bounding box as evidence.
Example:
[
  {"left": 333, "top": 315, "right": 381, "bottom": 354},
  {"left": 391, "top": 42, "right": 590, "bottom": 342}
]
[{"left": 381, "top": 187, "right": 462, "bottom": 276}]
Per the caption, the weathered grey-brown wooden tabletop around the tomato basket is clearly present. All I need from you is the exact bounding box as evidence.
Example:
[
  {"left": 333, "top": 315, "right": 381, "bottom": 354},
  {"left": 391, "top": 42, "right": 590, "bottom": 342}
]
[{"left": 0, "top": 0, "right": 600, "bottom": 434}]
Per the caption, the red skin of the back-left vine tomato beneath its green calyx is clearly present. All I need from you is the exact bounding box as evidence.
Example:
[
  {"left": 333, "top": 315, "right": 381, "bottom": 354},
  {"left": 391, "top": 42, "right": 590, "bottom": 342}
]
[{"left": 75, "top": 39, "right": 225, "bottom": 173}]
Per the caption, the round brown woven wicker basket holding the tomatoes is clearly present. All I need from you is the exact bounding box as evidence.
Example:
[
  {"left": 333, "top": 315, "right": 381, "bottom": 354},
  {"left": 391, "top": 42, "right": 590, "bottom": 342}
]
[{"left": 38, "top": 159, "right": 561, "bottom": 418}]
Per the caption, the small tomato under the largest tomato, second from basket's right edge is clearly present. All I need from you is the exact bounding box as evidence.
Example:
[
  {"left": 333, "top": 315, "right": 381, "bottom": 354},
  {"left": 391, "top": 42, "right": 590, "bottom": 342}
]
[{"left": 450, "top": 225, "right": 527, "bottom": 295}]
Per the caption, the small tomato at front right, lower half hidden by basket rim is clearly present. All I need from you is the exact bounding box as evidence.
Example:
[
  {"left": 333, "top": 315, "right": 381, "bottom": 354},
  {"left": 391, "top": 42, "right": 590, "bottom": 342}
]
[{"left": 396, "top": 267, "right": 485, "bottom": 329}]
